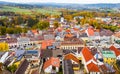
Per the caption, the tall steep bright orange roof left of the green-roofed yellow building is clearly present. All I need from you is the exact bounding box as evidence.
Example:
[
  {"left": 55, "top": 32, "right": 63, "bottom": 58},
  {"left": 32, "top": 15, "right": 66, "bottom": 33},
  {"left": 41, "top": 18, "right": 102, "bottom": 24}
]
[{"left": 82, "top": 47, "right": 96, "bottom": 62}]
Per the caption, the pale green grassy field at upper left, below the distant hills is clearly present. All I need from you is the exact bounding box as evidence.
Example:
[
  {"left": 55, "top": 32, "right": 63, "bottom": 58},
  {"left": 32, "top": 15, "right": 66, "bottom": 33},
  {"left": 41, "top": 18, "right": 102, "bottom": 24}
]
[{"left": 0, "top": 6, "right": 60, "bottom": 15}]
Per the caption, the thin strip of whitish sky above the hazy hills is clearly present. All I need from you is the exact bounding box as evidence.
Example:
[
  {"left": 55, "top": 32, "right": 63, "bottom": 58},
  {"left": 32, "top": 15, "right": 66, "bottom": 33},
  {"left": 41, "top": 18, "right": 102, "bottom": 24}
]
[{"left": 0, "top": 0, "right": 120, "bottom": 4}]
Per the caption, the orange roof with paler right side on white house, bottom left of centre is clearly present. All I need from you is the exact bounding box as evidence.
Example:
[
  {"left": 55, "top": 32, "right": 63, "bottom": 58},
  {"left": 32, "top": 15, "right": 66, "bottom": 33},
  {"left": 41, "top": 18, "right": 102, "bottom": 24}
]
[{"left": 43, "top": 57, "right": 60, "bottom": 69}]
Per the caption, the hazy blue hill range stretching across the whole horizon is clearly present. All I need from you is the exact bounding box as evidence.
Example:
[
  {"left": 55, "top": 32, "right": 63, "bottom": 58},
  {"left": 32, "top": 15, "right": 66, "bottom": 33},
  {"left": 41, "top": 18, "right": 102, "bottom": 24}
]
[{"left": 0, "top": 1, "right": 120, "bottom": 9}]
